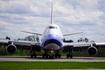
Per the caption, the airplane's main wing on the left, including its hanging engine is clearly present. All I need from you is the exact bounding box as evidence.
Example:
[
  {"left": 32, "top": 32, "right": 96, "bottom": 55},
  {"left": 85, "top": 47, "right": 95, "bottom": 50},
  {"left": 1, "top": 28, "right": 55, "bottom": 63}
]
[{"left": 0, "top": 39, "right": 41, "bottom": 53}]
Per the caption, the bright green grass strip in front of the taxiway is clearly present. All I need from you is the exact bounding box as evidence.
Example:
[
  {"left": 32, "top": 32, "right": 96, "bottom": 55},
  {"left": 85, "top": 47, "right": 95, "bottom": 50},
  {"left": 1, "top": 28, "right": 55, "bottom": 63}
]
[{"left": 0, "top": 62, "right": 105, "bottom": 70}]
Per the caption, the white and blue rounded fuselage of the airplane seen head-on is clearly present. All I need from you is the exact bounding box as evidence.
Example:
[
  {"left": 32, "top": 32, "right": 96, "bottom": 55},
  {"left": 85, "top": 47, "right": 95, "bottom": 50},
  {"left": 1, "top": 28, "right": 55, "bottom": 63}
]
[{"left": 41, "top": 24, "right": 63, "bottom": 50}]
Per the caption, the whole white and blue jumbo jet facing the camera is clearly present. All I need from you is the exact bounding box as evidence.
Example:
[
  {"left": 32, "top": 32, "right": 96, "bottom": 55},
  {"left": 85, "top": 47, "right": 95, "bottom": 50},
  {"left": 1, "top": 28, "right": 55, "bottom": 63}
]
[{"left": 0, "top": 2, "right": 105, "bottom": 58}]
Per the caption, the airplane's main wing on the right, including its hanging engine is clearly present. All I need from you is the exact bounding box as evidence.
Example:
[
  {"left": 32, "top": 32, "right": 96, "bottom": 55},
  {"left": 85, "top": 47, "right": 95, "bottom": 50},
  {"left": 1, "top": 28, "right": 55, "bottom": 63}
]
[{"left": 64, "top": 42, "right": 105, "bottom": 55}]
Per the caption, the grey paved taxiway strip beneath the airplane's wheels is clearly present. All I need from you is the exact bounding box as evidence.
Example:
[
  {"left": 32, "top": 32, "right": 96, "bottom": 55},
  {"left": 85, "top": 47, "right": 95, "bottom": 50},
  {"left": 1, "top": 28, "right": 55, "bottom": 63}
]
[{"left": 0, "top": 56, "right": 105, "bottom": 62}]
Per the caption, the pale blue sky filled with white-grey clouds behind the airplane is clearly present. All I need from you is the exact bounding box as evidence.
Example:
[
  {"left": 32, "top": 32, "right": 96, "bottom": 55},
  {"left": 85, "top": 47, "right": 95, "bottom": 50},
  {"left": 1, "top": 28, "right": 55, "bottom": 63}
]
[{"left": 0, "top": 0, "right": 105, "bottom": 41}]
